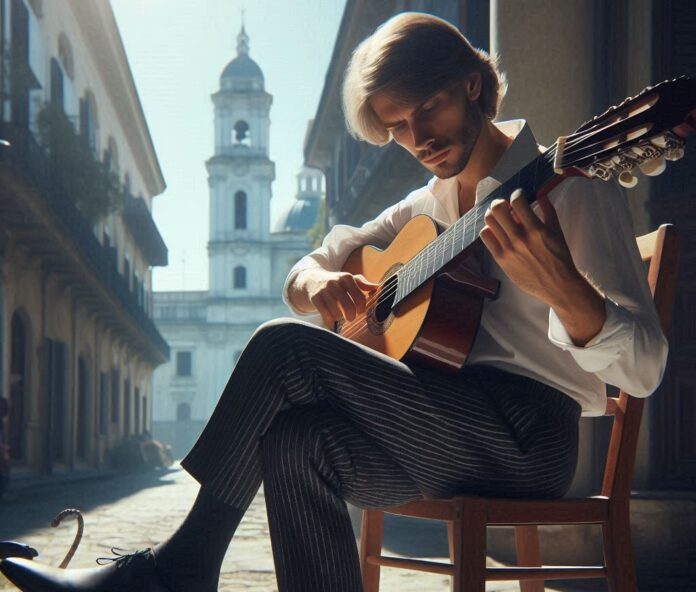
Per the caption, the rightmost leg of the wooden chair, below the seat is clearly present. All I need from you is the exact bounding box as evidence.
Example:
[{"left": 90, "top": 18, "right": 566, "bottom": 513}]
[{"left": 602, "top": 500, "right": 638, "bottom": 592}]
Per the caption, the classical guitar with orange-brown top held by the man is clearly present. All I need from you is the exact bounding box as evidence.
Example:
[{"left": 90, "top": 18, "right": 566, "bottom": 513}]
[{"left": 334, "top": 76, "right": 696, "bottom": 373}]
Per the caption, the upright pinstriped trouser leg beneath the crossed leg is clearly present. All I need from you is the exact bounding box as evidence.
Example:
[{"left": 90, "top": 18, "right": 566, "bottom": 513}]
[{"left": 263, "top": 404, "right": 422, "bottom": 592}]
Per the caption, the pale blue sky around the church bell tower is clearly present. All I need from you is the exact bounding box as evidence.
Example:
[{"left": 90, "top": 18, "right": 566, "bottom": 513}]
[{"left": 111, "top": 0, "right": 345, "bottom": 290}]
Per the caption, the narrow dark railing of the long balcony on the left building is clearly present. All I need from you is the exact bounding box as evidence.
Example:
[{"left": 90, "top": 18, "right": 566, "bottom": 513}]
[{"left": 0, "top": 123, "right": 169, "bottom": 359}]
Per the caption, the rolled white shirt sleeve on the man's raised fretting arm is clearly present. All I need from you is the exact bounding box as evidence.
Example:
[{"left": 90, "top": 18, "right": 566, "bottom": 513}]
[{"left": 548, "top": 178, "right": 668, "bottom": 397}]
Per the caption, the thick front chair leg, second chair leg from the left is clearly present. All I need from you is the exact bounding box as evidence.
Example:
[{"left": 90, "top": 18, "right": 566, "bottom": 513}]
[{"left": 450, "top": 499, "right": 486, "bottom": 592}]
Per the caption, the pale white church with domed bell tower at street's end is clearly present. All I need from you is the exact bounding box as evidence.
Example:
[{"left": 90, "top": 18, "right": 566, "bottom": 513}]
[{"left": 153, "top": 28, "right": 321, "bottom": 455}]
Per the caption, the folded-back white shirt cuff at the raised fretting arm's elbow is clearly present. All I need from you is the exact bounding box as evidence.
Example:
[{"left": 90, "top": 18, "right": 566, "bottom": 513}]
[{"left": 548, "top": 296, "right": 634, "bottom": 373}]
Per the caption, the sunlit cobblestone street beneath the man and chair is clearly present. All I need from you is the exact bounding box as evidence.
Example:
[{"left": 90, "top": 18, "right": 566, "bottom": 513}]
[{"left": 0, "top": 464, "right": 532, "bottom": 592}]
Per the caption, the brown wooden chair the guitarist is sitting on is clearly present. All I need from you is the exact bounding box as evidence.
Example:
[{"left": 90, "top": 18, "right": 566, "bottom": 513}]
[{"left": 360, "top": 225, "right": 679, "bottom": 592}]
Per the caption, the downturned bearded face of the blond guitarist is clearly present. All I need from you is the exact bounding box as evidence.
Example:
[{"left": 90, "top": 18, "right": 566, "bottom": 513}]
[{"left": 370, "top": 82, "right": 483, "bottom": 179}]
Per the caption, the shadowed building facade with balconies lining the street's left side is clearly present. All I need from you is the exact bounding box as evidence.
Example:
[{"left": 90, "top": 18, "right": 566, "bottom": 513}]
[{"left": 0, "top": 0, "right": 169, "bottom": 475}]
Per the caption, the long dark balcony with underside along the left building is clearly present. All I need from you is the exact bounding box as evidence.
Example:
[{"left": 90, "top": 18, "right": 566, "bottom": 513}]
[{"left": 0, "top": 123, "right": 169, "bottom": 363}]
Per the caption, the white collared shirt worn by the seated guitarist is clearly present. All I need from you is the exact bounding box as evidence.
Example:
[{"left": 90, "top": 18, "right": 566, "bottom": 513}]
[{"left": 283, "top": 120, "right": 667, "bottom": 416}]
